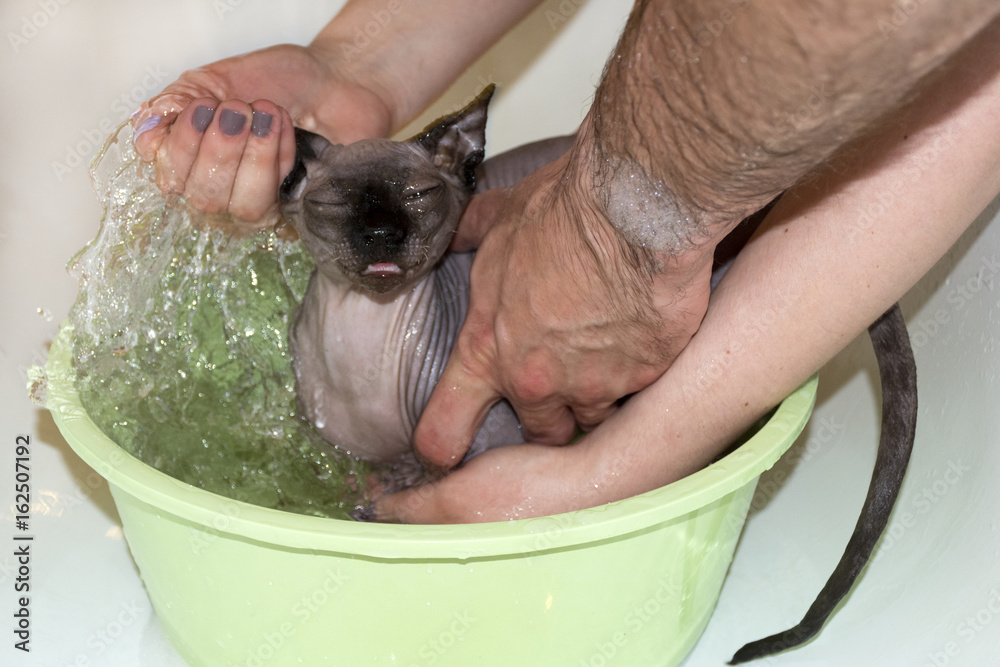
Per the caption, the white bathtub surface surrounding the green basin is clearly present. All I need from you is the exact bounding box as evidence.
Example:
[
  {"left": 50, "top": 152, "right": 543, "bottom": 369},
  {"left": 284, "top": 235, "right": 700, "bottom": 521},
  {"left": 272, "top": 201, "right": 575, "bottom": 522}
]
[{"left": 0, "top": 0, "right": 1000, "bottom": 667}]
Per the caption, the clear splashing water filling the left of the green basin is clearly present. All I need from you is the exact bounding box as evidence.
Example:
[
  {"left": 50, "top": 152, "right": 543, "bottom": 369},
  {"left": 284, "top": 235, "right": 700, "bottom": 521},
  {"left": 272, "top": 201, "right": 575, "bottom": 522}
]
[{"left": 70, "top": 125, "right": 370, "bottom": 518}]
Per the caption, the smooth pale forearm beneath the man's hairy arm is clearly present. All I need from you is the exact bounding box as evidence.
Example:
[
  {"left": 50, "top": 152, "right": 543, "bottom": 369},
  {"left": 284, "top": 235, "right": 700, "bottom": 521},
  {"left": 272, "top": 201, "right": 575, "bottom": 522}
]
[{"left": 584, "top": 14, "right": 1000, "bottom": 497}]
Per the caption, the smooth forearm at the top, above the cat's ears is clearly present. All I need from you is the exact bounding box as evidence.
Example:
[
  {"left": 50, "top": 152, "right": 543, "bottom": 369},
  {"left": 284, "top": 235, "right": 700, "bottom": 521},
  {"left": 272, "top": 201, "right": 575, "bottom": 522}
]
[{"left": 311, "top": 0, "right": 541, "bottom": 130}]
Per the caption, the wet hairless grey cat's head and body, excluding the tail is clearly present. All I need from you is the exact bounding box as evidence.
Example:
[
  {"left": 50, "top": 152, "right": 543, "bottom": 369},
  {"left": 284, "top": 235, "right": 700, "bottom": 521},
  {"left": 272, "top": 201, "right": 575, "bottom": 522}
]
[{"left": 281, "top": 87, "right": 572, "bottom": 490}]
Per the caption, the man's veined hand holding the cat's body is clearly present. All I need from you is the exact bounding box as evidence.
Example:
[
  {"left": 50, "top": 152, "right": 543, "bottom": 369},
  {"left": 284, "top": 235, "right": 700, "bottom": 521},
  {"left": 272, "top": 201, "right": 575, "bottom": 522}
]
[{"left": 414, "top": 155, "right": 711, "bottom": 468}]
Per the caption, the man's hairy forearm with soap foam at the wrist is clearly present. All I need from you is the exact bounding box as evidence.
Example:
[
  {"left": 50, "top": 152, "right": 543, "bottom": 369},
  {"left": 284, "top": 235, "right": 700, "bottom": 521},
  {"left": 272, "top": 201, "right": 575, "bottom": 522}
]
[{"left": 578, "top": 0, "right": 1000, "bottom": 254}]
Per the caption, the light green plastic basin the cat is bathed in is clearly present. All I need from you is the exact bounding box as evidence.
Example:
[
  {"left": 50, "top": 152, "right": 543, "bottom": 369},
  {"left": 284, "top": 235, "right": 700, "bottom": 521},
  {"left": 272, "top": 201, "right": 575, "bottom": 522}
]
[{"left": 46, "top": 320, "right": 816, "bottom": 667}]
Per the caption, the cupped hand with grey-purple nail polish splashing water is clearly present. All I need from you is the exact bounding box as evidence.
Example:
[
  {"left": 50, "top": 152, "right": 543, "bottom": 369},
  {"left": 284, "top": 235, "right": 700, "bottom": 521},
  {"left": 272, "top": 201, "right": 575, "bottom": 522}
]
[{"left": 132, "top": 45, "right": 391, "bottom": 221}]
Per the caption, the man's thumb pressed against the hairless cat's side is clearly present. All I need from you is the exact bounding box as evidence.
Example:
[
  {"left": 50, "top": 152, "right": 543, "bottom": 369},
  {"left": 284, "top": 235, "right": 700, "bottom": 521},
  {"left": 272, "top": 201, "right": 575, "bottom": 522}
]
[{"left": 413, "top": 340, "right": 500, "bottom": 469}]
